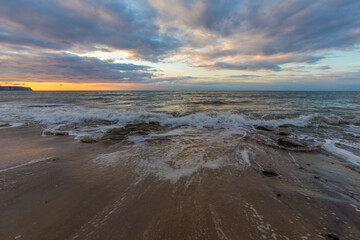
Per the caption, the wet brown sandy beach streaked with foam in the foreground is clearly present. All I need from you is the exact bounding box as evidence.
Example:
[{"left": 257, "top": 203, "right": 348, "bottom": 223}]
[{"left": 0, "top": 127, "right": 360, "bottom": 240}]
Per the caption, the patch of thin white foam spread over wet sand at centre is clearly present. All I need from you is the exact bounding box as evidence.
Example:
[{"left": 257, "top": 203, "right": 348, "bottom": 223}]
[{"left": 94, "top": 139, "right": 250, "bottom": 183}]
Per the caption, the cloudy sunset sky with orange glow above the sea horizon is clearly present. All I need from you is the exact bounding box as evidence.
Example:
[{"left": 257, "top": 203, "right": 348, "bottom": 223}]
[{"left": 0, "top": 0, "right": 360, "bottom": 90}]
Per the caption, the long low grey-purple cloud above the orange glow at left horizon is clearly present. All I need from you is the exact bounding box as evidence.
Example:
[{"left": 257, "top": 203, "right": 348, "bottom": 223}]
[{"left": 0, "top": 53, "right": 155, "bottom": 82}]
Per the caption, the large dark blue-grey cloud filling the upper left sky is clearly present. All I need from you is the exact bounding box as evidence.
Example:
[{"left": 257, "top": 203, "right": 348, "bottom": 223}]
[{"left": 0, "top": 0, "right": 179, "bottom": 60}]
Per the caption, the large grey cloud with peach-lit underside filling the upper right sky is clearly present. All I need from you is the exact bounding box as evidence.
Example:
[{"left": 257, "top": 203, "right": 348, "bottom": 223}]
[{"left": 150, "top": 0, "right": 360, "bottom": 71}]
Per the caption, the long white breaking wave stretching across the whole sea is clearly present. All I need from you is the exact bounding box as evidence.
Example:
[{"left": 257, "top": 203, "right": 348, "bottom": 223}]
[{"left": 0, "top": 104, "right": 360, "bottom": 129}]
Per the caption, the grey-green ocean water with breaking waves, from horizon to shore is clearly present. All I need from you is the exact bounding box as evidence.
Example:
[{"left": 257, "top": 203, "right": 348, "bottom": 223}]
[{"left": 0, "top": 91, "right": 360, "bottom": 168}]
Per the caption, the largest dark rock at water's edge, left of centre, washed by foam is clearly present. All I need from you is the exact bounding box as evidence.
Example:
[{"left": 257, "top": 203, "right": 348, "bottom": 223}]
[{"left": 102, "top": 122, "right": 161, "bottom": 141}]
